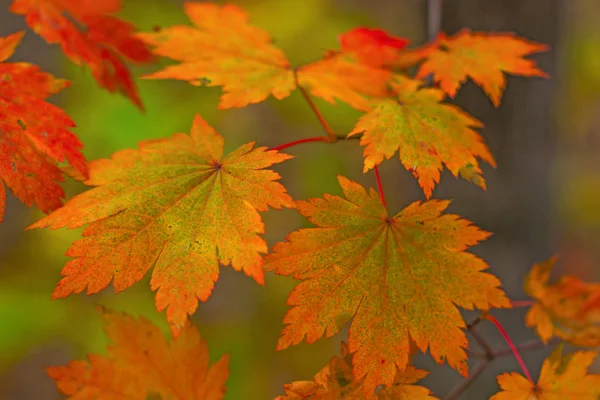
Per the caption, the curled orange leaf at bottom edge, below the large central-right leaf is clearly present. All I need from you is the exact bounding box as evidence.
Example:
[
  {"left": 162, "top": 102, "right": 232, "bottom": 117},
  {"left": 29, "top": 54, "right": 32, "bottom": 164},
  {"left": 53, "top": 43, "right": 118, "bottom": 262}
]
[{"left": 275, "top": 342, "right": 437, "bottom": 400}]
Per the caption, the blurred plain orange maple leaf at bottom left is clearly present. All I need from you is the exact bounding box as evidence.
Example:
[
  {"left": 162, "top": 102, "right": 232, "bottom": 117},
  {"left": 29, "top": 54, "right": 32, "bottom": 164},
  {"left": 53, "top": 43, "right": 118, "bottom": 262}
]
[{"left": 46, "top": 308, "right": 229, "bottom": 400}]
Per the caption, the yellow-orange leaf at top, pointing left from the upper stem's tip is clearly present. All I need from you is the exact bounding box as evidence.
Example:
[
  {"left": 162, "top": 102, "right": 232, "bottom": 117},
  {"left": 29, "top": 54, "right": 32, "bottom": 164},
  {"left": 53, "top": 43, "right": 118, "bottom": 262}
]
[{"left": 138, "top": 2, "right": 296, "bottom": 109}]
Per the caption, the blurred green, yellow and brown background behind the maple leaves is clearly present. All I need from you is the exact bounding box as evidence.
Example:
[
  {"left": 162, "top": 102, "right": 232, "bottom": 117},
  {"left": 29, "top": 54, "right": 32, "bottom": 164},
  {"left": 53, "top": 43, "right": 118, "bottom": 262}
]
[{"left": 0, "top": 0, "right": 600, "bottom": 400}]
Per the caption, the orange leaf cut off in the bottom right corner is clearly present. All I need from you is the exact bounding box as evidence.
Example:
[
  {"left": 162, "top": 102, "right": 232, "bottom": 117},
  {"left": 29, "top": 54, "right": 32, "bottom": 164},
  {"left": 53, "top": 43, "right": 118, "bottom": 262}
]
[{"left": 490, "top": 345, "right": 600, "bottom": 400}]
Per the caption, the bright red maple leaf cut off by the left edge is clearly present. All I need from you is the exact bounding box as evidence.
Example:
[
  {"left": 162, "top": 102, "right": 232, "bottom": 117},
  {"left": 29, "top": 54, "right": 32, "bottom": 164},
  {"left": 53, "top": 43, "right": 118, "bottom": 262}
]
[{"left": 0, "top": 32, "right": 88, "bottom": 221}]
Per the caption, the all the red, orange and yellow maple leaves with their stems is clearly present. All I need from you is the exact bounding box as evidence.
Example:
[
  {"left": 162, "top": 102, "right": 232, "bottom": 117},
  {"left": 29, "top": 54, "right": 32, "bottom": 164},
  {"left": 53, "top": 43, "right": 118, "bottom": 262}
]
[{"left": 0, "top": 0, "right": 600, "bottom": 400}]
